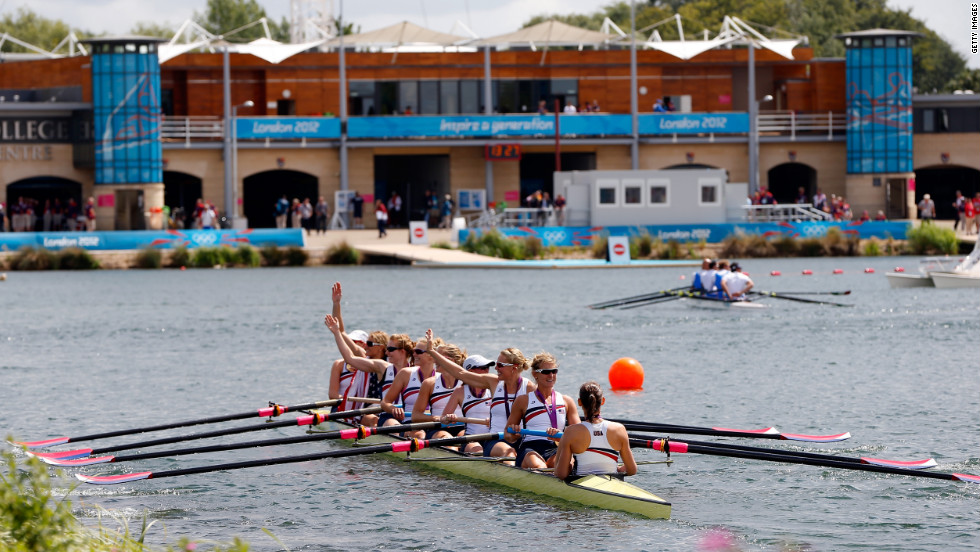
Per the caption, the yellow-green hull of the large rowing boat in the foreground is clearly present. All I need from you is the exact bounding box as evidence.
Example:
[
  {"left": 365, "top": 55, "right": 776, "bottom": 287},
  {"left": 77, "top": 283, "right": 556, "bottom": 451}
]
[{"left": 313, "top": 421, "right": 670, "bottom": 519}]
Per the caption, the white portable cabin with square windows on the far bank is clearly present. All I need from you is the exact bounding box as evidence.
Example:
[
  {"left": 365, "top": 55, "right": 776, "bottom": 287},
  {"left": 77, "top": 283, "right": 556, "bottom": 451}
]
[{"left": 554, "top": 168, "right": 748, "bottom": 226}]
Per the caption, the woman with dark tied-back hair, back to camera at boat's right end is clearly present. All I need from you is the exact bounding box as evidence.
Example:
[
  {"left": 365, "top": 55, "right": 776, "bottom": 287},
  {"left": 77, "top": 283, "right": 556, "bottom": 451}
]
[{"left": 555, "top": 381, "right": 636, "bottom": 479}]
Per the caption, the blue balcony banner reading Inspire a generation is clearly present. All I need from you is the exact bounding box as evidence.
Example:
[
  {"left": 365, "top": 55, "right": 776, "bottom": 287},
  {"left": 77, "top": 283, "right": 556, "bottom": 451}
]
[{"left": 347, "top": 113, "right": 632, "bottom": 139}]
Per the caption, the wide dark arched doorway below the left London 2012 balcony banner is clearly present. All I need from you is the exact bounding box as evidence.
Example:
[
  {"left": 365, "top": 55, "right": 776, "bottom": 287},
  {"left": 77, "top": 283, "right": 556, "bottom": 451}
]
[{"left": 242, "top": 169, "right": 318, "bottom": 228}]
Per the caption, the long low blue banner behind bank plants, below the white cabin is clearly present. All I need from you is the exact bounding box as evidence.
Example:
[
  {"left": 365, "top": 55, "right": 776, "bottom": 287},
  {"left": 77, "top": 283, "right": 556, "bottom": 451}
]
[{"left": 459, "top": 221, "right": 911, "bottom": 247}]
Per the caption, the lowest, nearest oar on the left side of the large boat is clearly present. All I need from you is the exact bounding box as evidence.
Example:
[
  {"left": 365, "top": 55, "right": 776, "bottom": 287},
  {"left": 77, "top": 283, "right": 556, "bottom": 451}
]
[{"left": 75, "top": 433, "right": 503, "bottom": 485}]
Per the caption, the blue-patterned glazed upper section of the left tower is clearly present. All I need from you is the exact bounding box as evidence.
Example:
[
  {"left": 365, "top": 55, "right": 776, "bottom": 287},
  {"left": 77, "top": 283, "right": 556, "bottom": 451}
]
[{"left": 92, "top": 44, "right": 163, "bottom": 184}]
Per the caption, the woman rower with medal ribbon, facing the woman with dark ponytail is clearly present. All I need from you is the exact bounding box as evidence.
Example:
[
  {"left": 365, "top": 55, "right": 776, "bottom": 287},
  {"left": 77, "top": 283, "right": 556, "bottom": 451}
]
[{"left": 504, "top": 353, "right": 579, "bottom": 469}]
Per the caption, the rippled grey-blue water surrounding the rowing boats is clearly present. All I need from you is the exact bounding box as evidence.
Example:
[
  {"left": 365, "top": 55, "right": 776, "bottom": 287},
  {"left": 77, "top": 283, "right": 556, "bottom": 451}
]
[{"left": 0, "top": 258, "right": 980, "bottom": 551}]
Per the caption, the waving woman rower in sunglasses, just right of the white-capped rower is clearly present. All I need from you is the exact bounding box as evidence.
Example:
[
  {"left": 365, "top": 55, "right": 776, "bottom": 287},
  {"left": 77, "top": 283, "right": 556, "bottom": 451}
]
[{"left": 429, "top": 330, "right": 537, "bottom": 458}]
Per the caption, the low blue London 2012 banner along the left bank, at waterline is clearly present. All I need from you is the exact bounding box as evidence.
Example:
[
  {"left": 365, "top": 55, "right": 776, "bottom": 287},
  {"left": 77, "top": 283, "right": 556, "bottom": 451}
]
[{"left": 0, "top": 228, "right": 304, "bottom": 251}]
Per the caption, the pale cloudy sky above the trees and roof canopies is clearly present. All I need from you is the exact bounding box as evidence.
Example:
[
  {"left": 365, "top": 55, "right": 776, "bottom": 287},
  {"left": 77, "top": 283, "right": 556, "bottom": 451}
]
[{"left": 7, "top": 0, "right": 980, "bottom": 69}]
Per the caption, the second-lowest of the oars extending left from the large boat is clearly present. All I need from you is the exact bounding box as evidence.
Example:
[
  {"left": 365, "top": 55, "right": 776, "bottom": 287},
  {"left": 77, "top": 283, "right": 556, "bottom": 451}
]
[{"left": 41, "top": 422, "right": 443, "bottom": 467}]
